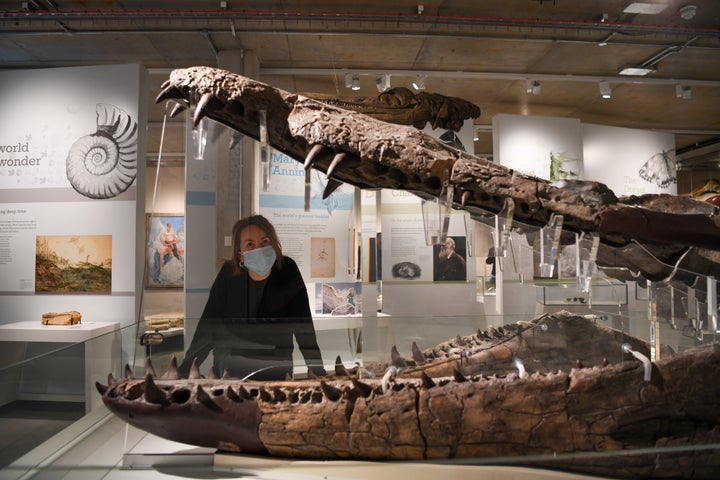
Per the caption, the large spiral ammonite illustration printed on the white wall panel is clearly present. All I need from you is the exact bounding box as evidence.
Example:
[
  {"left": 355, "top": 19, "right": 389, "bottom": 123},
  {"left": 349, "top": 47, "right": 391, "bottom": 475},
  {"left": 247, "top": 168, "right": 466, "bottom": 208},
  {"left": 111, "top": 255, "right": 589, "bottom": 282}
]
[{"left": 67, "top": 103, "right": 137, "bottom": 199}]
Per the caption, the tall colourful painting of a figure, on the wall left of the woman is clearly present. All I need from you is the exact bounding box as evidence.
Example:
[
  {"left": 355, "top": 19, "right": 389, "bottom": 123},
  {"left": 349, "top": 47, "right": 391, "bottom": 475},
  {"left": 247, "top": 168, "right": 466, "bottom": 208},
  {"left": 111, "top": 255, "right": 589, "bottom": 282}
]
[{"left": 145, "top": 213, "right": 185, "bottom": 288}]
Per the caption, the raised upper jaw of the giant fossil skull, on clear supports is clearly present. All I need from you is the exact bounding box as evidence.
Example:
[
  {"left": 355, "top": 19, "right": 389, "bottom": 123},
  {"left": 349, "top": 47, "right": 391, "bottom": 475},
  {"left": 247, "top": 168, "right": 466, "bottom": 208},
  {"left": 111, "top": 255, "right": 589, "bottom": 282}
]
[{"left": 158, "top": 67, "right": 720, "bottom": 285}]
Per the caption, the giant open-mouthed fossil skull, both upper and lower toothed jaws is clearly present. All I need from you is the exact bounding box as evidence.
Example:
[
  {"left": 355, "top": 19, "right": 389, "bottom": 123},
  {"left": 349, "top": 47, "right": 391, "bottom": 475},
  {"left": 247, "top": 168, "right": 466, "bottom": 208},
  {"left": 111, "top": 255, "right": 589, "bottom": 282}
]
[{"left": 98, "top": 67, "right": 720, "bottom": 478}]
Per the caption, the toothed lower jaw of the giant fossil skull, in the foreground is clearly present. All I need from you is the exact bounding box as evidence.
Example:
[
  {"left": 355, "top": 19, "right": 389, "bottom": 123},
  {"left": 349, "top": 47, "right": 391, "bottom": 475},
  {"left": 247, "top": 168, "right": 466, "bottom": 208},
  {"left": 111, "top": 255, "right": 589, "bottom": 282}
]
[{"left": 97, "top": 312, "right": 720, "bottom": 479}]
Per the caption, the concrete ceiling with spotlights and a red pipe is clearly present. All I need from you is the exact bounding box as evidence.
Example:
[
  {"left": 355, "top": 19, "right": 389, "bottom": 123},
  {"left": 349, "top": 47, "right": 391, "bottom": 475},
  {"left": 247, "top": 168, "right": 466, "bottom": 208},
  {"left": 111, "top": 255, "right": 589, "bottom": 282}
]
[{"left": 0, "top": 0, "right": 720, "bottom": 169}]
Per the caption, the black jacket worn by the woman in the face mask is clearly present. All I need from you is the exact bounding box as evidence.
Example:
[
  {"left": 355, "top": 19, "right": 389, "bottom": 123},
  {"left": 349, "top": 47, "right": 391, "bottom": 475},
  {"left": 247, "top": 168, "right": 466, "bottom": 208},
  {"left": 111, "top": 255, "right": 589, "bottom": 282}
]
[{"left": 179, "top": 257, "right": 325, "bottom": 378}]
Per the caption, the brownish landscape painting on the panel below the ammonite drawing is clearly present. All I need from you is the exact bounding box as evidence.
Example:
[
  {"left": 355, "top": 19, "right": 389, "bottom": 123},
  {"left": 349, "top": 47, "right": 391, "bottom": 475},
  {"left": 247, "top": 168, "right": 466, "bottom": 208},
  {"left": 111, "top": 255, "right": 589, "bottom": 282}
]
[{"left": 35, "top": 235, "right": 112, "bottom": 293}]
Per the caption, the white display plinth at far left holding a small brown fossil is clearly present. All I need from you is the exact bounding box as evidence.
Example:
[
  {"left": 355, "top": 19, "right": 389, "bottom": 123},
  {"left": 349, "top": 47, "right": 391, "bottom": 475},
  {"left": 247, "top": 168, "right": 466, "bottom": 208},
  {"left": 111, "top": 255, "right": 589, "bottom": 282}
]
[{"left": 0, "top": 321, "right": 121, "bottom": 412}]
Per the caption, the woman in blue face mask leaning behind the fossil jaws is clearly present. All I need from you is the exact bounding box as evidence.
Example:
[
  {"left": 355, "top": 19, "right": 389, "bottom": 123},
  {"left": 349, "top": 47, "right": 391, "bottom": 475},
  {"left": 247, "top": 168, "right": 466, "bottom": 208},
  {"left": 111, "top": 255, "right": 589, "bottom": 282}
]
[{"left": 179, "top": 215, "right": 325, "bottom": 380}]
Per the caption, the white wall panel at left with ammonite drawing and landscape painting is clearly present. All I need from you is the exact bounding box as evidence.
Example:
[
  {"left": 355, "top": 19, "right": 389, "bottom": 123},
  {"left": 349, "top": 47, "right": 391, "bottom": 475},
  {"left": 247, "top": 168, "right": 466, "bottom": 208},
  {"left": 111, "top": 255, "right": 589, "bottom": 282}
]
[{"left": 0, "top": 65, "right": 147, "bottom": 325}]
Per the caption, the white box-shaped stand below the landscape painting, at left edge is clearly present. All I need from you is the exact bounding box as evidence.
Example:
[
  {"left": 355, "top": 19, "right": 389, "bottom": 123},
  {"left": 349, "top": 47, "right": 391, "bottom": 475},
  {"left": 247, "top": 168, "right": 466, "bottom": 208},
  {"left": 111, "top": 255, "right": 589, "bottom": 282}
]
[{"left": 0, "top": 321, "right": 121, "bottom": 412}]
